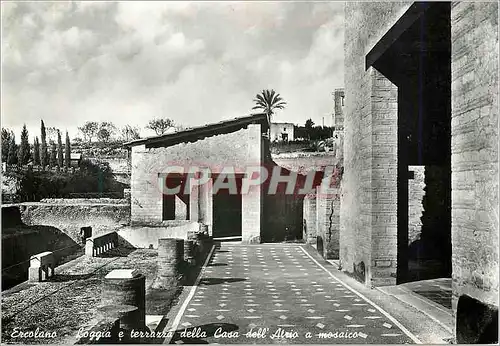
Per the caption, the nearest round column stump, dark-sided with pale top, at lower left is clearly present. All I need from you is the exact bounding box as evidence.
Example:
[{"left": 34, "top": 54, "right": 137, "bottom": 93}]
[{"left": 101, "top": 269, "right": 146, "bottom": 331}]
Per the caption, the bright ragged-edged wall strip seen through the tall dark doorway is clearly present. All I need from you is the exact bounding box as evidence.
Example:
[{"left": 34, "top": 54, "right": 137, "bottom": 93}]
[{"left": 408, "top": 166, "right": 425, "bottom": 246}]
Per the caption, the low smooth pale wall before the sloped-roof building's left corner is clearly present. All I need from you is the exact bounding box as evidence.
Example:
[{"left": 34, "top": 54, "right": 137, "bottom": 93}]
[{"left": 118, "top": 221, "right": 200, "bottom": 249}]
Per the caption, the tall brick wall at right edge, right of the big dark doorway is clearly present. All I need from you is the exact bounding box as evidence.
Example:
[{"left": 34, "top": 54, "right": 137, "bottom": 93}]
[{"left": 451, "top": 2, "right": 499, "bottom": 324}]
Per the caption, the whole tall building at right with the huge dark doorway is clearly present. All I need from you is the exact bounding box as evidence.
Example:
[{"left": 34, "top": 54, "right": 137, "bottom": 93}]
[{"left": 339, "top": 2, "right": 499, "bottom": 343}]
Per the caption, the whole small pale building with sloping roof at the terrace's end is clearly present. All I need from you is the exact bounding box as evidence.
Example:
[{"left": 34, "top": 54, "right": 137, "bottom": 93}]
[{"left": 127, "top": 114, "right": 269, "bottom": 242}]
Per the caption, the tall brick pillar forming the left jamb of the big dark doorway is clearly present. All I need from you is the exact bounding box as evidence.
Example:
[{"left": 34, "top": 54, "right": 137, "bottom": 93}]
[{"left": 366, "top": 67, "right": 398, "bottom": 286}]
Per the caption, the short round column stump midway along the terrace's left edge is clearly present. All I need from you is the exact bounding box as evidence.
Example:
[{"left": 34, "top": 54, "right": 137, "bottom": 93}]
[{"left": 155, "top": 238, "right": 184, "bottom": 287}]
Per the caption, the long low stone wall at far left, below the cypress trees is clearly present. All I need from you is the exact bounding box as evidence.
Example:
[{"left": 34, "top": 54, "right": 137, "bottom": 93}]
[{"left": 2, "top": 200, "right": 130, "bottom": 243}]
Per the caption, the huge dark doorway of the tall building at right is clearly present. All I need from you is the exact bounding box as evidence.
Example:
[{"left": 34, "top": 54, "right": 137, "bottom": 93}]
[{"left": 373, "top": 2, "right": 451, "bottom": 284}]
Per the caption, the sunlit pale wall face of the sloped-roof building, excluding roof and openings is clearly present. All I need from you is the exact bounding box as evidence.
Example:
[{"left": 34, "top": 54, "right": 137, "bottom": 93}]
[{"left": 131, "top": 125, "right": 262, "bottom": 241}]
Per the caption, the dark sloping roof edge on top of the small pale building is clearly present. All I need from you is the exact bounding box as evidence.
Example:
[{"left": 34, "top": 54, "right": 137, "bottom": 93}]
[{"left": 124, "top": 113, "right": 269, "bottom": 147}]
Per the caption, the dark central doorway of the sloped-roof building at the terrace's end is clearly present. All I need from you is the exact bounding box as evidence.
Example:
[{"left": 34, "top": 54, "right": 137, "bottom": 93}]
[{"left": 212, "top": 176, "right": 242, "bottom": 238}]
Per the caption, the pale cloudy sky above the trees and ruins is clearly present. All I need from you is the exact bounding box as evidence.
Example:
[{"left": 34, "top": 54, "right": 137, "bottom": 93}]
[{"left": 1, "top": 1, "right": 344, "bottom": 138}]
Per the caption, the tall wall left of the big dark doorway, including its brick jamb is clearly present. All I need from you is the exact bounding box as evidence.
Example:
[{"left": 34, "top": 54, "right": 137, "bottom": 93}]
[{"left": 340, "top": 2, "right": 411, "bottom": 284}]
